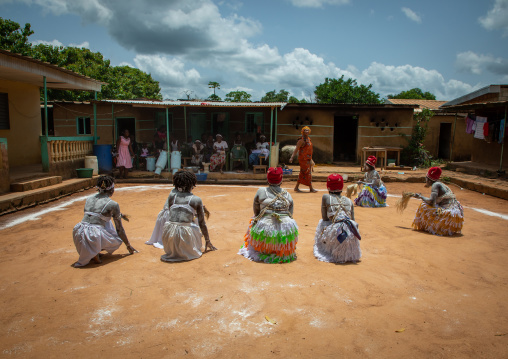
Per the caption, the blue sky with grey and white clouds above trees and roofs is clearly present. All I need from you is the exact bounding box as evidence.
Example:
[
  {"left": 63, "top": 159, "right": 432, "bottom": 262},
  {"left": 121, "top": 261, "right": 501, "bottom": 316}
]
[{"left": 0, "top": 0, "right": 508, "bottom": 101}]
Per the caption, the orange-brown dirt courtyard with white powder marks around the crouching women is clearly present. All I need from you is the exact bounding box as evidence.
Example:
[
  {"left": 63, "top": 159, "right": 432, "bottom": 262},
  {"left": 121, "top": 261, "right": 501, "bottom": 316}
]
[{"left": 0, "top": 182, "right": 508, "bottom": 358}]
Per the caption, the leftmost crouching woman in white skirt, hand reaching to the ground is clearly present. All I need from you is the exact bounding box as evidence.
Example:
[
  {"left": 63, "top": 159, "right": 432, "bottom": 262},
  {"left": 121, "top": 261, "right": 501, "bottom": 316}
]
[{"left": 72, "top": 176, "right": 136, "bottom": 267}]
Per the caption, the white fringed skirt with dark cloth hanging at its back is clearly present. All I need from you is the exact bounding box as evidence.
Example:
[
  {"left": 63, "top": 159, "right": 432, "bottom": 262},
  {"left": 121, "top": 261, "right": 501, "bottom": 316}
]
[{"left": 314, "top": 219, "right": 362, "bottom": 263}]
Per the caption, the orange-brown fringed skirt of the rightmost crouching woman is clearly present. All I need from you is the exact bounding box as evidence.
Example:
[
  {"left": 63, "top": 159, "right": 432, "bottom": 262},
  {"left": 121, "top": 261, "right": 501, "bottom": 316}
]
[{"left": 413, "top": 201, "right": 464, "bottom": 236}]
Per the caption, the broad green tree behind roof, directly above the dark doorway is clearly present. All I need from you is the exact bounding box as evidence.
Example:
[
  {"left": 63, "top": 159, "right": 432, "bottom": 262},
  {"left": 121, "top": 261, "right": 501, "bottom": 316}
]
[{"left": 314, "top": 75, "right": 381, "bottom": 104}]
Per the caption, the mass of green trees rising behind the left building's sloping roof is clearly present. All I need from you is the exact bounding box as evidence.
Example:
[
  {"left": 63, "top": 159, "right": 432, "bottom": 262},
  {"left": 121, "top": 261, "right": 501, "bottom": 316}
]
[{"left": 0, "top": 18, "right": 162, "bottom": 101}]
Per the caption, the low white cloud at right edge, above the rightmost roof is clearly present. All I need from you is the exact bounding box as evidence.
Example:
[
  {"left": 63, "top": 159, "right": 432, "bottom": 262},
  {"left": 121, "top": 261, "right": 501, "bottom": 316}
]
[{"left": 455, "top": 51, "right": 508, "bottom": 79}]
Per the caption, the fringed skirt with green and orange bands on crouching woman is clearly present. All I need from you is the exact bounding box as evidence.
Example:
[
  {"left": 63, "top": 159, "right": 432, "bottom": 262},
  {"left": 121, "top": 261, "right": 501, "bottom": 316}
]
[{"left": 238, "top": 214, "right": 298, "bottom": 263}]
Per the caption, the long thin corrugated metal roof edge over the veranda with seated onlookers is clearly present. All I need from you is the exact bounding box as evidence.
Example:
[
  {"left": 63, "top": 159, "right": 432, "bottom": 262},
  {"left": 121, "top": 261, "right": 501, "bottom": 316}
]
[{"left": 99, "top": 100, "right": 287, "bottom": 110}]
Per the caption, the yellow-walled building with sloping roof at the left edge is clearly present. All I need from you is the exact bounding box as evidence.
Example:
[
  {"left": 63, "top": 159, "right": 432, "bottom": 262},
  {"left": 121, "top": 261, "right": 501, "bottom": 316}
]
[{"left": 0, "top": 50, "right": 102, "bottom": 191}]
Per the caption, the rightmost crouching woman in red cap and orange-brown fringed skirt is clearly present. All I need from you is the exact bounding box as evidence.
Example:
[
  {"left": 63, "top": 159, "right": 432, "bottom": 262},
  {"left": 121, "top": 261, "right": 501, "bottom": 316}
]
[{"left": 413, "top": 167, "right": 464, "bottom": 236}]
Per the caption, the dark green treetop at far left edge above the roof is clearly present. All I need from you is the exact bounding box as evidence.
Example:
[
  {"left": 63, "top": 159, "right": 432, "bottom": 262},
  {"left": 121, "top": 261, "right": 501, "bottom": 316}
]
[{"left": 0, "top": 17, "right": 34, "bottom": 55}]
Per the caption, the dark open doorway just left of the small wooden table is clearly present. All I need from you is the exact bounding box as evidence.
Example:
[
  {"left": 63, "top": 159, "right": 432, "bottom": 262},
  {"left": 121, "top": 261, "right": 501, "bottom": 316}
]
[{"left": 333, "top": 116, "right": 358, "bottom": 162}]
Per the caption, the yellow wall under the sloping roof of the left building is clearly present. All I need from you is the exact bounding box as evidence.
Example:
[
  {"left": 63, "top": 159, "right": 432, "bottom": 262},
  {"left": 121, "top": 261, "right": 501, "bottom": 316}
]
[{"left": 0, "top": 79, "right": 42, "bottom": 167}]
